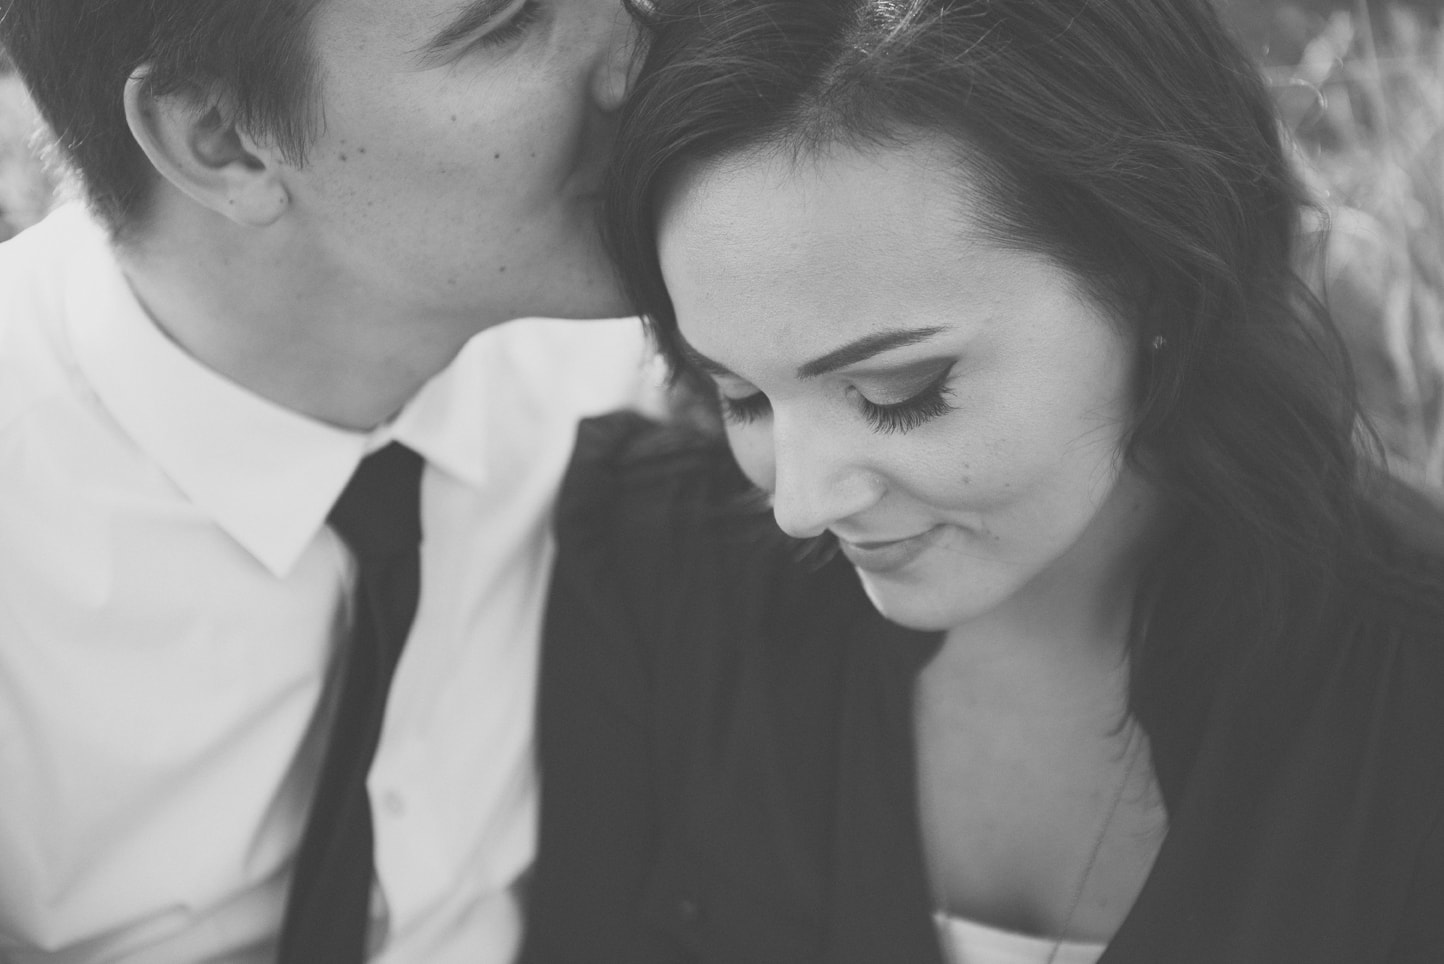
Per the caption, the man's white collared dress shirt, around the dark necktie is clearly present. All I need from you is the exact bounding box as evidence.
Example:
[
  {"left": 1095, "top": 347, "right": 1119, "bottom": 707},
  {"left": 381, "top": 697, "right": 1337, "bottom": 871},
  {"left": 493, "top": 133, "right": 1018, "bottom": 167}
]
[{"left": 0, "top": 209, "right": 647, "bottom": 964}]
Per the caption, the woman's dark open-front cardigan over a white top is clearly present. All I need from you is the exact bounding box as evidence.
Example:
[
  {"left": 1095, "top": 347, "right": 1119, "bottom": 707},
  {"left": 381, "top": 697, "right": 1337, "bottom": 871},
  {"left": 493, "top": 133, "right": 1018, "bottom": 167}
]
[{"left": 521, "top": 416, "right": 1444, "bottom": 964}]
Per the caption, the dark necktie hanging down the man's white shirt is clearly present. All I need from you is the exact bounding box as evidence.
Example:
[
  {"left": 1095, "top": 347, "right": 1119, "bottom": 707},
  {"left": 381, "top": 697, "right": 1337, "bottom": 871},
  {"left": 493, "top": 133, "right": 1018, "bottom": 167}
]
[{"left": 279, "top": 442, "right": 422, "bottom": 964}]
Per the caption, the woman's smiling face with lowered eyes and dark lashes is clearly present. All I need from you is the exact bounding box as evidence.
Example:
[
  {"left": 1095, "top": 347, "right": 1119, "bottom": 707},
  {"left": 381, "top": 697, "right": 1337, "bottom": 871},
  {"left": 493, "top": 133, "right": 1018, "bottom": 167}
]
[{"left": 660, "top": 143, "right": 1148, "bottom": 629}]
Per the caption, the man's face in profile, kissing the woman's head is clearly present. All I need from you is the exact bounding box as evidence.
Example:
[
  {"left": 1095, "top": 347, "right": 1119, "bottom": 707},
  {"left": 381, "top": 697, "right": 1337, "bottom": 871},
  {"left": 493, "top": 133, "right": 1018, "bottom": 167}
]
[{"left": 286, "top": 0, "right": 631, "bottom": 328}]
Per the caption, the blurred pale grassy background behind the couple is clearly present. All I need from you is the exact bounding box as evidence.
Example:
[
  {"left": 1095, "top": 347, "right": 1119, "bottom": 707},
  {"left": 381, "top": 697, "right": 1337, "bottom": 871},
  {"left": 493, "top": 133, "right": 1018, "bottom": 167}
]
[{"left": 0, "top": 0, "right": 1444, "bottom": 488}]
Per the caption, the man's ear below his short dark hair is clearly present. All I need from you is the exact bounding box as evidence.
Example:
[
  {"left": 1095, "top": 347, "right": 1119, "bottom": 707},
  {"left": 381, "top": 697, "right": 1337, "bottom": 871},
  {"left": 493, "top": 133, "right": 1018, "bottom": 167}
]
[{"left": 126, "top": 68, "right": 290, "bottom": 227}]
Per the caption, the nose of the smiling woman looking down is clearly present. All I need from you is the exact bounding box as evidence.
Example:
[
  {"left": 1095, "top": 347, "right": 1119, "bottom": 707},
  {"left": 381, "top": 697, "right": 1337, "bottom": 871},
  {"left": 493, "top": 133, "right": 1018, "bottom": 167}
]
[{"left": 773, "top": 423, "right": 885, "bottom": 538}]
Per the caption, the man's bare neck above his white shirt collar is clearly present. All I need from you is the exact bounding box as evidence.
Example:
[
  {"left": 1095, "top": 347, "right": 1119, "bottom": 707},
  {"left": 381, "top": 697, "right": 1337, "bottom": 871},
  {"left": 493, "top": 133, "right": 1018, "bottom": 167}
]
[{"left": 118, "top": 202, "right": 487, "bottom": 430}]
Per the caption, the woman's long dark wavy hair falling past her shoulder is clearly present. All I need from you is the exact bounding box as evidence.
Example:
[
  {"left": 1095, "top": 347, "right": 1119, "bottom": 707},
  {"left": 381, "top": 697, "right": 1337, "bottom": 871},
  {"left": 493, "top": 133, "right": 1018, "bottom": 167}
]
[{"left": 608, "top": 0, "right": 1426, "bottom": 773}]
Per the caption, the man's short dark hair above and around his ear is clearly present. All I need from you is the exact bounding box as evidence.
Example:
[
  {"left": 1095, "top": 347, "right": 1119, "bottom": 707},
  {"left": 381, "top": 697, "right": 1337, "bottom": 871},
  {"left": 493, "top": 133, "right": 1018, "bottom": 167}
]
[{"left": 0, "top": 0, "right": 321, "bottom": 234}]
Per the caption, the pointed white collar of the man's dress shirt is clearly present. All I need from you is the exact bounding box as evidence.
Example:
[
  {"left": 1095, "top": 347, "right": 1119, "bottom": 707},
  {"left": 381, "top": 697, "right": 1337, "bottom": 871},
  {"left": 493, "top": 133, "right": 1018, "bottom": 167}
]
[{"left": 66, "top": 215, "right": 487, "bottom": 577}]
